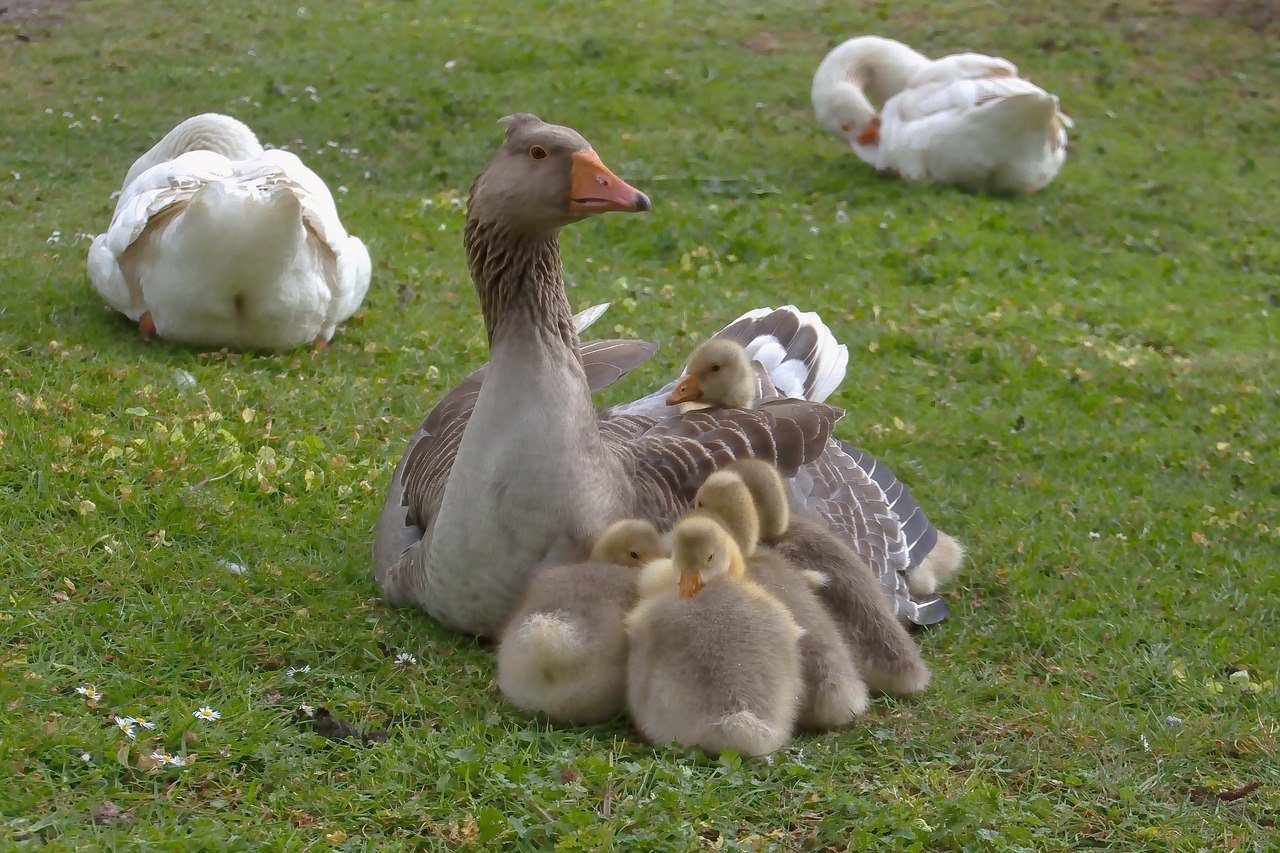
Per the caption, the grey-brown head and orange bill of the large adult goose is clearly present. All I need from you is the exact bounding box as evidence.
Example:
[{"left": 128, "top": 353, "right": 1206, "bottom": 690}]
[{"left": 467, "top": 113, "right": 650, "bottom": 240}]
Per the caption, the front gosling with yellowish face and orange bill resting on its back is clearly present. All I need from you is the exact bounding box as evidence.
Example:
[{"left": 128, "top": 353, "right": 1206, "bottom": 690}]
[{"left": 626, "top": 516, "right": 804, "bottom": 756}]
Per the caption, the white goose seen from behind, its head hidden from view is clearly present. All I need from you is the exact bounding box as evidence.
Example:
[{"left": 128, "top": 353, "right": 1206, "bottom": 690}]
[{"left": 88, "top": 113, "right": 371, "bottom": 350}]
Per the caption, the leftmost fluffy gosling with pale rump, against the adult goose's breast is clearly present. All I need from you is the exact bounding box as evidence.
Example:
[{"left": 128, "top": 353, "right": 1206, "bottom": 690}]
[{"left": 498, "top": 519, "right": 666, "bottom": 725}]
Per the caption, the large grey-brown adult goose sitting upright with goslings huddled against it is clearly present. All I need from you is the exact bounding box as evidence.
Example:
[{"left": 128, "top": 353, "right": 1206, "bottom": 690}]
[{"left": 372, "top": 113, "right": 962, "bottom": 635}]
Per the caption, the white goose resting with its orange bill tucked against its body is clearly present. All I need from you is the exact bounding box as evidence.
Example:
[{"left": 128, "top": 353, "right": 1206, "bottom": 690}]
[{"left": 812, "top": 36, "right": 1071, "bottom": 193}]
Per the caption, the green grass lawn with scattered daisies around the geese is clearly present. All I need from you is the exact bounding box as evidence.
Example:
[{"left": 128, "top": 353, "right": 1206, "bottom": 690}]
[{"left": 0, "top": 0, "right": 1280, "bottom": 850}]
